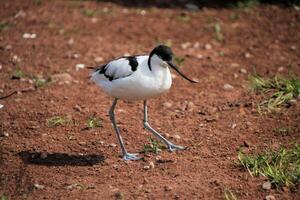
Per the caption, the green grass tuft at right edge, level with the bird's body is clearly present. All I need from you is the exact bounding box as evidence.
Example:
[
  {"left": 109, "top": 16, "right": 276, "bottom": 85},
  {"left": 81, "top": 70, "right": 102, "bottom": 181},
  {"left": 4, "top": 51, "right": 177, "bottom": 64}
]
[{"left": 250, "top": 75, "right": 300, "bottom": 113}]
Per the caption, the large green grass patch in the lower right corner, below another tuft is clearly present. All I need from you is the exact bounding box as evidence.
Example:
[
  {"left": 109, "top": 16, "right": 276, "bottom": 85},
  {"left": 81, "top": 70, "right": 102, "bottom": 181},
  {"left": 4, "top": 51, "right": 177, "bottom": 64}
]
[{"left": 238, "top": 144, "right": 300, "bottom": 186}]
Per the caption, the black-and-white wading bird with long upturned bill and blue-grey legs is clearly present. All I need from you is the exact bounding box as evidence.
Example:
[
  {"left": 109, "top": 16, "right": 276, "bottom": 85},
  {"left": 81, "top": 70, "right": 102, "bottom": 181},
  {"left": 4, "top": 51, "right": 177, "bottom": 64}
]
[{"left": 91, "top": 44, "right": 197, "bottom": 160}]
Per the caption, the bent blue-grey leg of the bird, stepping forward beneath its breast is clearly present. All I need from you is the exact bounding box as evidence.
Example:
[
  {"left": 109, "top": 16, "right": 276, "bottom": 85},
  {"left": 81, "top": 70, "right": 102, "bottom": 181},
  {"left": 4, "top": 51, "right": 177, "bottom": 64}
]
[{"left": 144, "top": 100, "right": 186, "bottom": 151}]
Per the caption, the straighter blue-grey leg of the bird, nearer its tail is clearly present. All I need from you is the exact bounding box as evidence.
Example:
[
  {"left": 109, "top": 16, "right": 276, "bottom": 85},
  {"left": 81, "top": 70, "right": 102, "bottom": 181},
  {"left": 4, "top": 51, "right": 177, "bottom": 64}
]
[{"left": 109, "top": 98, "right": 140, "bottom": 160}]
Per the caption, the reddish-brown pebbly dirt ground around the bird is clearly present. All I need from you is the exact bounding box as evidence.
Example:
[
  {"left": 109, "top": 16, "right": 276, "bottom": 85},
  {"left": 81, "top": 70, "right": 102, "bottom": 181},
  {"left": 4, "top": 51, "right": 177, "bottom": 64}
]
[{"left": 0, "top": 0, "right": 300, "bottom": 199}]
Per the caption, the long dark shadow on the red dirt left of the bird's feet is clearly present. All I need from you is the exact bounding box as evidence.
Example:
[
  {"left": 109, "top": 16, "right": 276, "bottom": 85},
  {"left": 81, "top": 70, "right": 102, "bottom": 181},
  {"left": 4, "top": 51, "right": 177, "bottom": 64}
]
[{"left": 18, "top": 151, "right": 105, "bottom": 166}]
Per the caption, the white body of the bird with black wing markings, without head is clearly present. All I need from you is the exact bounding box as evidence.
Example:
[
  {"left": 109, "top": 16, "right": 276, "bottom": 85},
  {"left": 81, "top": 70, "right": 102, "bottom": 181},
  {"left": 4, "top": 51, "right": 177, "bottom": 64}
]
[{"left": 91, "top": 55, "right": 172, "bottom": 101}]
